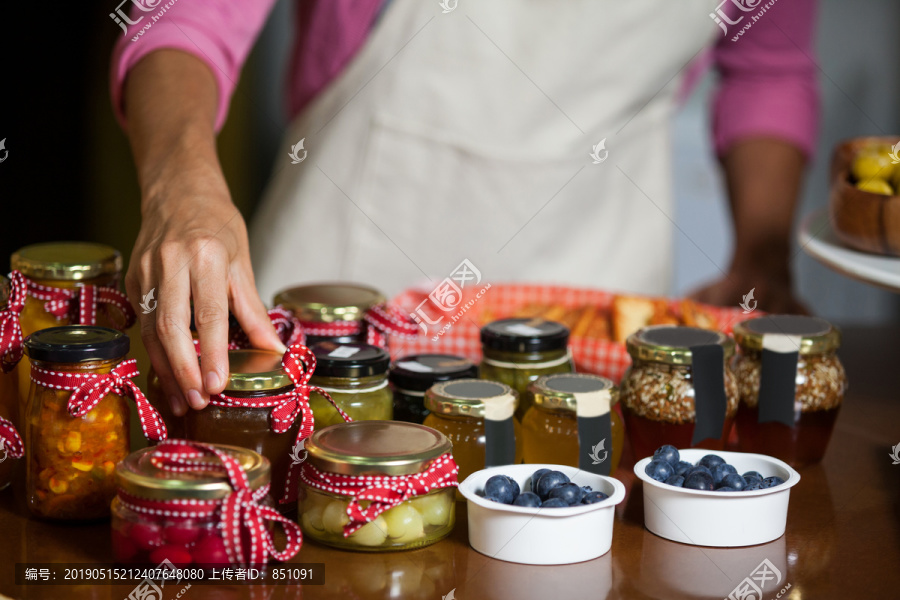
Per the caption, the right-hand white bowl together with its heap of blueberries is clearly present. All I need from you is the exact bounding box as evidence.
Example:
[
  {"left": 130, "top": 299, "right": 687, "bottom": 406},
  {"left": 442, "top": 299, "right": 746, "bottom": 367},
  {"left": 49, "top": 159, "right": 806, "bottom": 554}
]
[{"left": 634, "top": 445, "right": 800, "bottom": 547}]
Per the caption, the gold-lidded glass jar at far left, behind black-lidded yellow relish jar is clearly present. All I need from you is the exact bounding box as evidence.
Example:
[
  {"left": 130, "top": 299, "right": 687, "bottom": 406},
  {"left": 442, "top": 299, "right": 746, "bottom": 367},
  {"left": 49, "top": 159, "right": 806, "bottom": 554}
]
[{"left": 10, "top": 242, "right": 131, "bottom": 413}]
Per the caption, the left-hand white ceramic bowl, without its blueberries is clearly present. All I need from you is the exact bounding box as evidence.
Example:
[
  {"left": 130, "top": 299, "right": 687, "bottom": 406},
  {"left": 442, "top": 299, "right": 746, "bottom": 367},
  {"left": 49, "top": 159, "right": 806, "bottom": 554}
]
[{"left": 459, "top": 465, "right": 625, "bottom": 565}]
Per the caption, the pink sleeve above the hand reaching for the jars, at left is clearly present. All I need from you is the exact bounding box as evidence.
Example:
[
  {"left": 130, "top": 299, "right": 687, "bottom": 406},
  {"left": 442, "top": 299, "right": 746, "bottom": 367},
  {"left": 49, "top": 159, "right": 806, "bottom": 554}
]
[{"left": 110, "top": 0, "right": 275, "bottom": 130}]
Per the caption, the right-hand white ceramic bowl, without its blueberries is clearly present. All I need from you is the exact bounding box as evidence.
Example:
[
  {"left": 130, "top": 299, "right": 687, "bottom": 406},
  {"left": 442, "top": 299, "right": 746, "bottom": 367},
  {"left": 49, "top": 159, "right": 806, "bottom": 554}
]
[{"left": 634, "top": 449, "right": 800, "bottom": 547}]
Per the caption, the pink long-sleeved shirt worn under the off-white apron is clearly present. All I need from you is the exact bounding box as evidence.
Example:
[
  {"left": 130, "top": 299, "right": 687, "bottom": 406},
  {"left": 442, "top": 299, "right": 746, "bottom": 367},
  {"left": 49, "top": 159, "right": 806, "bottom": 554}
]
[{"left": 111, "top": 0, "right": 819, "bottom": 156}]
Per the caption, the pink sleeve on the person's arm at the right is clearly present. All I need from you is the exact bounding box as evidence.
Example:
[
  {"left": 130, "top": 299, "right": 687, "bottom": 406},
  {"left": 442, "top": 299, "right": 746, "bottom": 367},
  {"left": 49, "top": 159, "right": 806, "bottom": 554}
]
[{"left": 713, "top": 0, "right": 819, "bottom": 156}]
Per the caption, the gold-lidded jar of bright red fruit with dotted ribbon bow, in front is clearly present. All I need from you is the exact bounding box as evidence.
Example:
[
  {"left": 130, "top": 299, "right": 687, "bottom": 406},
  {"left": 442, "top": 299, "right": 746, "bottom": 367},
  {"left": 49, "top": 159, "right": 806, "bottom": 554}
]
[{"left": 112, "top": 440, "right": 301, "bottom": 570}]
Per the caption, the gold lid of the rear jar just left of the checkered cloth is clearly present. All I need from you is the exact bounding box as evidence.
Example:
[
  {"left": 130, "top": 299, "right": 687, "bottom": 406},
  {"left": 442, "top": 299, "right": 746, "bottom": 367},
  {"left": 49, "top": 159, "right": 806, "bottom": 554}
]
[{"left": 275, "top": 283, "right": 385, "bottom": 323}]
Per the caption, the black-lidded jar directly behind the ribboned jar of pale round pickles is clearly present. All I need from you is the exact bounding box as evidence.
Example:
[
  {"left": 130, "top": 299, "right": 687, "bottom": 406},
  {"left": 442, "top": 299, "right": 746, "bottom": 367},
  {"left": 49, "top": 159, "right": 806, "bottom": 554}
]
[{"left": 309, "top": 342, "right": 394, "bottom": 429}]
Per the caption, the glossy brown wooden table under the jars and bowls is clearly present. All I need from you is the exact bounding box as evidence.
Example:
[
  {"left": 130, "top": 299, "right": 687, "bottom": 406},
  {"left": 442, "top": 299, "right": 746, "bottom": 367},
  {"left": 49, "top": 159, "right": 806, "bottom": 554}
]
[{"left": 0, "top": 328, "right": 900, "bottom": 600}]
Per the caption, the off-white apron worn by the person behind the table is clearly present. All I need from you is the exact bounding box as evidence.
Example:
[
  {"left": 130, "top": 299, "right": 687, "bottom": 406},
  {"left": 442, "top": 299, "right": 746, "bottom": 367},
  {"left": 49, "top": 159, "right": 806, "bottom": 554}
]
[{"left": 251, "top": 0, "right": 719, "bottom": 301}]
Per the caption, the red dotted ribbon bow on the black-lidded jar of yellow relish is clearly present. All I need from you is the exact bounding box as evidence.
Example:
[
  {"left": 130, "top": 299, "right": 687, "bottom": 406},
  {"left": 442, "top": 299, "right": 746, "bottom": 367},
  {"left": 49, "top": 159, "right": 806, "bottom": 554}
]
[{"left": 31, "top": 358, "right": 166, "bottom": 441}]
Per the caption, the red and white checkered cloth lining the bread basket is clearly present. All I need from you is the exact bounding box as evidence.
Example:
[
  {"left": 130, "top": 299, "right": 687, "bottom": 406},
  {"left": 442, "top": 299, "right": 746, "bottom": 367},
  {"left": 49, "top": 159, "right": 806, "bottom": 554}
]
[{"left": 390, "top": 284, "right": 748, "bottom": 382}]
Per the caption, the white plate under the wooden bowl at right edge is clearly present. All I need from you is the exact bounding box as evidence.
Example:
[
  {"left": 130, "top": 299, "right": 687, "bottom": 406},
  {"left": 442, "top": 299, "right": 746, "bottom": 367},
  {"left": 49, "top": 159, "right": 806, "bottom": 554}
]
[{"left": 797, "top": 209, "right": 900, "bottom": 292}]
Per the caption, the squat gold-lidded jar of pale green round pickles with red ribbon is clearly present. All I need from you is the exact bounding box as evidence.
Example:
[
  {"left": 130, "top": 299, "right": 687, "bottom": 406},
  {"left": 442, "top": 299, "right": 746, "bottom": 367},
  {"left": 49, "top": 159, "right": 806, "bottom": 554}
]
[{"left": 299, "top": 421, "right": 457, "bottom": 551}]
